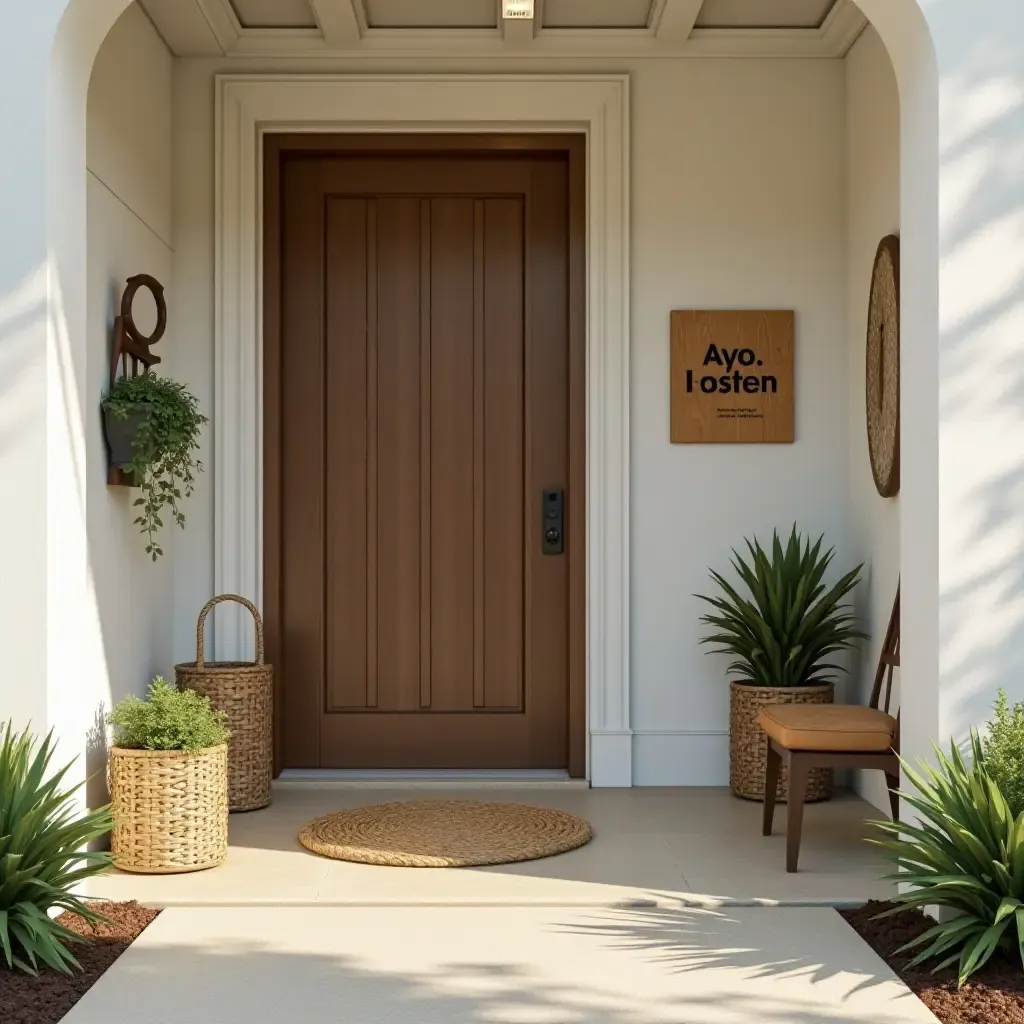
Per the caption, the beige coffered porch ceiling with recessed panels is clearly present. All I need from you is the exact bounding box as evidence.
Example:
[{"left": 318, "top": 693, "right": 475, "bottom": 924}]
[{"left": 137, "top": 0, "right": 866, "bottom": 57}]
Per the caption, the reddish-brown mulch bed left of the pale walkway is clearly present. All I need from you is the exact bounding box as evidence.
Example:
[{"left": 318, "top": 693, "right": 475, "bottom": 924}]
[{"left": 0, "top": 903, "right": 160, "bottom": 1024}]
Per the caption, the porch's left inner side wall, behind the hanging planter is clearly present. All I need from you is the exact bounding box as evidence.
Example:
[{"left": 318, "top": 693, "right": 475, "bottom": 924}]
[{"left": 86, "top": 4, "right": 173, "bottom": 798}]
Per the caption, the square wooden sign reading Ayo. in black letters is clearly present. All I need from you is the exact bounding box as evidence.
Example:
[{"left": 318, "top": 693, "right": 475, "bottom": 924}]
[{"left": 672, "top": 309, "right": 795, "bottom": 444}]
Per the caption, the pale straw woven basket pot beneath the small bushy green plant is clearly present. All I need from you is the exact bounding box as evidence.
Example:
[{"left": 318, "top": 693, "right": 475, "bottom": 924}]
[{"left": 110, "top": 743, "right": 227, "bottom": 874}]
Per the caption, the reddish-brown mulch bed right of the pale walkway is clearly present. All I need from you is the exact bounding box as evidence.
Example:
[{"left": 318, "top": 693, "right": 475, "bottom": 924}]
[{"left": 840, "top": 902, "right": 1024, "bottom": 1024}]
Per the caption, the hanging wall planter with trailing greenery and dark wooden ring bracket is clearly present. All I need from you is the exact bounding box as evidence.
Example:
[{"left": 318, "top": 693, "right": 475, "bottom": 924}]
[{"left": 101, "top": 274, "right": 207, "bottom": 561}]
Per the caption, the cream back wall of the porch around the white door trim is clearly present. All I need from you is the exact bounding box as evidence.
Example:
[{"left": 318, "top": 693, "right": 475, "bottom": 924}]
[{"left": 172, "top": 51, "right": 850, "bottom": 784}]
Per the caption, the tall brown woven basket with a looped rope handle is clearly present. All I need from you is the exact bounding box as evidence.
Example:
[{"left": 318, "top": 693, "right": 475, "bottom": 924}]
[{"left": 174, "top": 594, "right": 273, "bottom": 811}]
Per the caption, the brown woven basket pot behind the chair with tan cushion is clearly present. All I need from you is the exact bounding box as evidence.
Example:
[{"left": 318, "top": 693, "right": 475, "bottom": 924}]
[{"left": 729, "top": 683, "right": 836, "bottom": 804}]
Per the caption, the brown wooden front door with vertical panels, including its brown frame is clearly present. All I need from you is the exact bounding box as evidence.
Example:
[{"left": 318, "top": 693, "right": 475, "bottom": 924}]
[{"left": 265, "top": 139, "right": 584, "bottom": 774}]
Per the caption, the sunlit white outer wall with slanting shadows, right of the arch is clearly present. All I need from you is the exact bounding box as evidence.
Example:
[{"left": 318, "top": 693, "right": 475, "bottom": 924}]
[{"left": 929, "top": 2, "right": 1024, "bottom": 738}]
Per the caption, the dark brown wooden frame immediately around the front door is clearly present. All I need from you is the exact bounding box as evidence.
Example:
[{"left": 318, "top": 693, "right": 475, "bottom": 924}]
[{"left": 262, "top": 132, "right": 587, "bottom": 778}]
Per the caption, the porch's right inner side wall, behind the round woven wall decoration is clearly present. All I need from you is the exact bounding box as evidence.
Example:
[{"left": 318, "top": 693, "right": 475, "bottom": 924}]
[{"left": 846, "top": 29, "right": 905, "bottom": 810}]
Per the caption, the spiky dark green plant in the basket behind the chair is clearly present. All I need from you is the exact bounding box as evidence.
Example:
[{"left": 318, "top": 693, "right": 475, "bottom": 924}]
[{"left": 697, "top": 526, "right": 865, "bottom": 686}]
